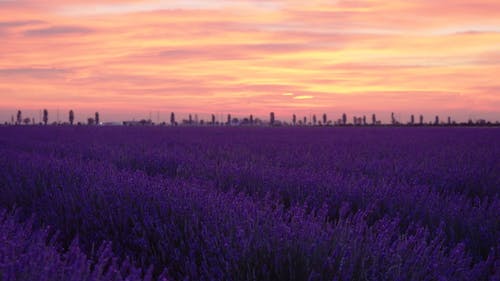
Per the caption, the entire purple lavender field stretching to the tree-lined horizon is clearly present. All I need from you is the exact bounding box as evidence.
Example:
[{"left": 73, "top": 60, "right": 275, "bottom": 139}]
[{"left": 0, "top": 126, "right": 500, "bottom": 281}]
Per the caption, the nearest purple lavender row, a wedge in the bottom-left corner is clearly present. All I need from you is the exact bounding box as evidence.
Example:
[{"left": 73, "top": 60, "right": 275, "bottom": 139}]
[{"left": 0, "top": 209, "right": 167, "bottom": 281}]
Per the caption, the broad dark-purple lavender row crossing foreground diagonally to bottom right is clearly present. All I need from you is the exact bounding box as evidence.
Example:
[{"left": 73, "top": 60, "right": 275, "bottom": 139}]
[{"left": 0, "top": 144, "right": 499, "bottom": 280}]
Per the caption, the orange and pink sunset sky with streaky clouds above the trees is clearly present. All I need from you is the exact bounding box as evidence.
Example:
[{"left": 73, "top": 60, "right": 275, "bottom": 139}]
[{"left": 0, "top": 0, "right": 500, "bottom": 122}]
